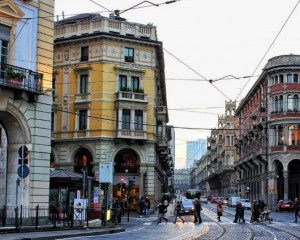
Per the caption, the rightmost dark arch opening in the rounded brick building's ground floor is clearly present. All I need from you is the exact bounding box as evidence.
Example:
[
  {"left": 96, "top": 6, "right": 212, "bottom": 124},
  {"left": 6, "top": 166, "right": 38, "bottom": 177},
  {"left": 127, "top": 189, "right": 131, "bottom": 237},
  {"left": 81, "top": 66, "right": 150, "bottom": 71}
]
[{"left": 287, "top": 159, "right": 300, "bottom": 200}]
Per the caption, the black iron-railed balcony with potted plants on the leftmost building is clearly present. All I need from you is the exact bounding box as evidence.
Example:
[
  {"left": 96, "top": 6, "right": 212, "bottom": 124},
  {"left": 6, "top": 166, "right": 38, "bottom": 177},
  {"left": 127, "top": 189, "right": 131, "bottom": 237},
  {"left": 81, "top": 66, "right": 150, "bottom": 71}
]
[{"left": 0, "top": 63, "right": 43, "bottom": 95}]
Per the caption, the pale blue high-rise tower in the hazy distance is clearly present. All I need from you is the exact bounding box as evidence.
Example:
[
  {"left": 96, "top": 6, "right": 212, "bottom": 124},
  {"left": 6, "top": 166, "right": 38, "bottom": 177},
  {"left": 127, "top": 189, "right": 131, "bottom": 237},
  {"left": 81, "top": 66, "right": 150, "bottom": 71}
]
[{"left": 186, "top": 139, "right": 206, "bottom": 168}]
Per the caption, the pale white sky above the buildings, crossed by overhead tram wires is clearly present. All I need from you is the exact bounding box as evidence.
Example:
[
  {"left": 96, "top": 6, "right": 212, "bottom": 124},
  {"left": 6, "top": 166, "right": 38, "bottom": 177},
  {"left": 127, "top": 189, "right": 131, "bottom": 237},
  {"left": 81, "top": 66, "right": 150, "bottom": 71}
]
[{"left": 55, "top": 0, "right": 300, "bottom": 168}]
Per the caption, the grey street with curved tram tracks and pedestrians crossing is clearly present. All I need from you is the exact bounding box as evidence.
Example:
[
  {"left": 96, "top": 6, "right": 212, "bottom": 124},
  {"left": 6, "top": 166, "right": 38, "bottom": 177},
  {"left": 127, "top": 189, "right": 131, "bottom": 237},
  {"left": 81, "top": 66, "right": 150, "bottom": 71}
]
[{"left": 61, "top": 203, "right": 300, "bottom": 240}]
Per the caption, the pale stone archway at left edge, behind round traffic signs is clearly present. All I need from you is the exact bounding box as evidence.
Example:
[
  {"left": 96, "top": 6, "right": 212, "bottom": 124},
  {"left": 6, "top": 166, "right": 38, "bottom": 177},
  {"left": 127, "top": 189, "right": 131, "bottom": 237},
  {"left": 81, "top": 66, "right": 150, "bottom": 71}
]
[{"left": 0, "top": 109, "right": 30, "bottom": 206}]
